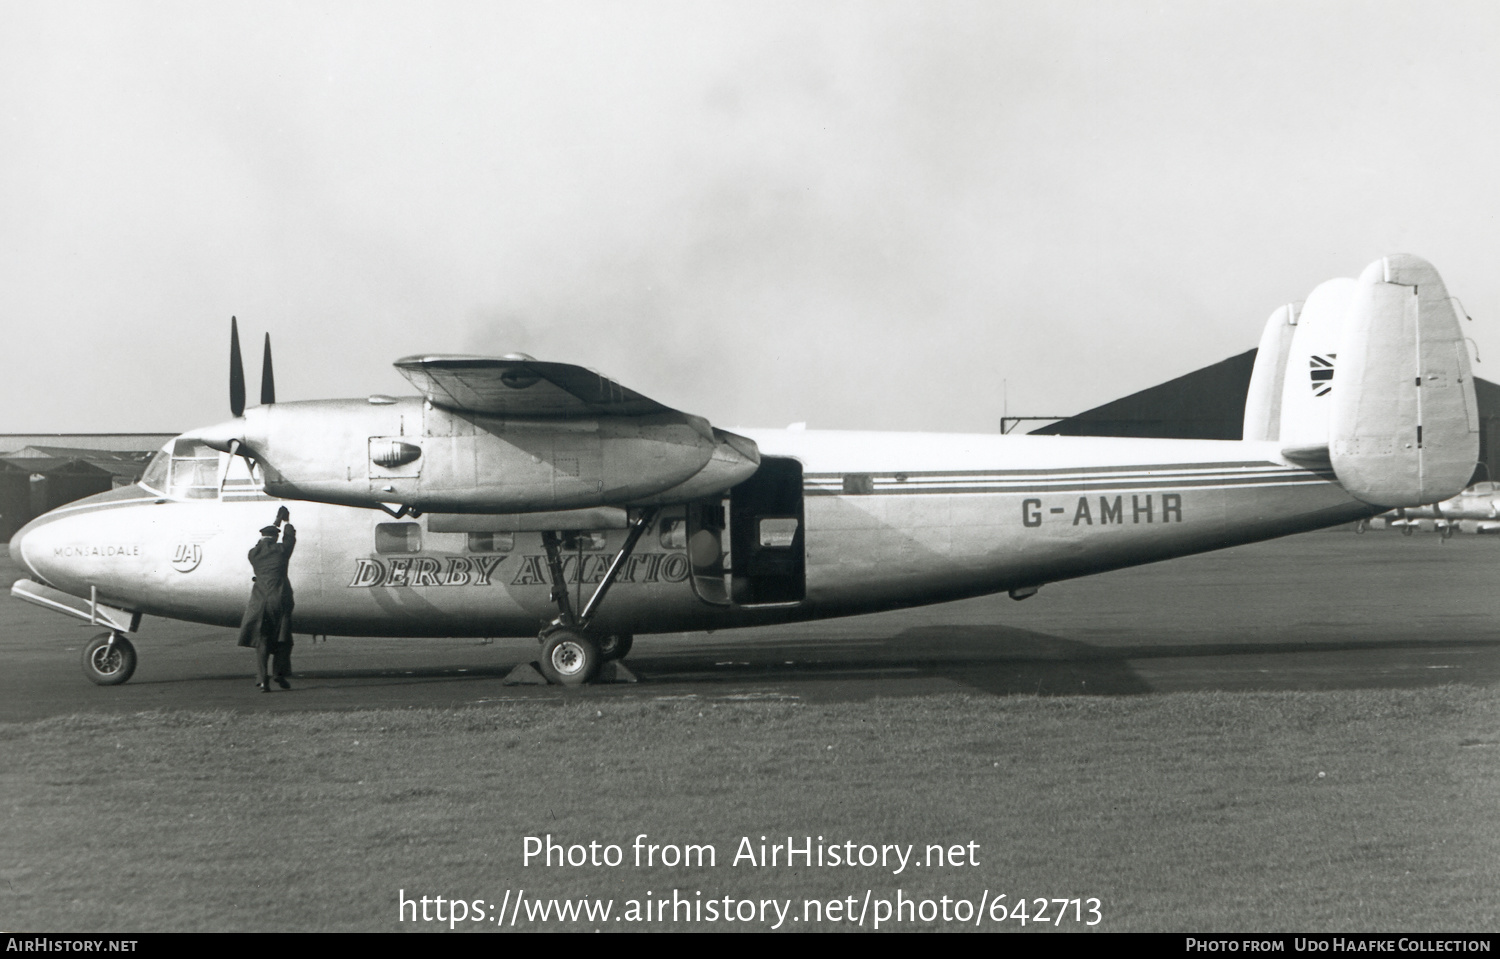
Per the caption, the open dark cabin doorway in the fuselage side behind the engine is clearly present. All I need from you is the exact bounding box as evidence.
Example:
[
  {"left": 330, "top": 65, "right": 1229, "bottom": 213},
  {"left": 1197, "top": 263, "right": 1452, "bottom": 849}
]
[{"left": 728, "top": 456, "right": 807, "bottom": 606}]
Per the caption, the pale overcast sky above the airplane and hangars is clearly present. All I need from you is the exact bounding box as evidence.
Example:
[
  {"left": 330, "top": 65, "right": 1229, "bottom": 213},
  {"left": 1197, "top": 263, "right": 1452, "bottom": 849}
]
[{"left": 0, "top": 0, "right": 1500, "bottom": 432}]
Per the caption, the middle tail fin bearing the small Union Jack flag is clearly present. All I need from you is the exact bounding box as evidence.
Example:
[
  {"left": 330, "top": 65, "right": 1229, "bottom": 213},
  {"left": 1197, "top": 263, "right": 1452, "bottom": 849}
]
[{"left": 1278, "top": 276, "right": 1359, "bottom": 462}]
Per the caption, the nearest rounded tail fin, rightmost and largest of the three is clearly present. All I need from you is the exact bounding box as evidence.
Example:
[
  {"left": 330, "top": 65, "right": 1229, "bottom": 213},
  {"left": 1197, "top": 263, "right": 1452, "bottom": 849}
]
[{"left": 1329, "top": 255, "right": 1479, "bottom": 506}]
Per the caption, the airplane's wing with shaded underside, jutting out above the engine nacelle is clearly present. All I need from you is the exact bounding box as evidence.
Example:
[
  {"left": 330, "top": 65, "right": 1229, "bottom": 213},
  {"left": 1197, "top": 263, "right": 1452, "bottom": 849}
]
[{"left": 396, "top": 356, "right": 678, "bottom": 417}]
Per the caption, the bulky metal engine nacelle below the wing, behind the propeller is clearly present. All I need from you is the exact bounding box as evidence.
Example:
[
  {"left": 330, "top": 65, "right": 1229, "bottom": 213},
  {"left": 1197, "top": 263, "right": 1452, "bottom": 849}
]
[{"left": 186, "top": 396, "right": 761, "bottom": 513}]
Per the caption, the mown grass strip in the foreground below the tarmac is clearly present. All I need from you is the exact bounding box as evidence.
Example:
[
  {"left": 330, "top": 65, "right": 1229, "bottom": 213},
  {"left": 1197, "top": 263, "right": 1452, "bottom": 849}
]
[{"left": 0, "top": 686, "right": 1500, "bottom": 932}]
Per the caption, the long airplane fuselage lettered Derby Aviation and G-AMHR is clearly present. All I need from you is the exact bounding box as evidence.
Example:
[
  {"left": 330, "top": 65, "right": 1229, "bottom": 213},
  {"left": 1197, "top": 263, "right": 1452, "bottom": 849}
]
[{"left": 11, "top": 431, "right": 1379, "bottom": 636}]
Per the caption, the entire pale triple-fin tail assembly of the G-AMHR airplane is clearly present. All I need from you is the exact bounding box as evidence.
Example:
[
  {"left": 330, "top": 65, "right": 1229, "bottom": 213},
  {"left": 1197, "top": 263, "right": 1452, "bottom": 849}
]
[{"left": 1244, "top": 254, "right": 1479, "bottom": 507}]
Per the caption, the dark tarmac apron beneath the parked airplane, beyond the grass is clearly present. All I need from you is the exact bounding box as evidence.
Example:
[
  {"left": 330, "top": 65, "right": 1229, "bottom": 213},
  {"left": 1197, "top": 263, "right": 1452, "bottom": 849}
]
[{"left": 0, "top": 530, "right": 1500, "bottom": 722}]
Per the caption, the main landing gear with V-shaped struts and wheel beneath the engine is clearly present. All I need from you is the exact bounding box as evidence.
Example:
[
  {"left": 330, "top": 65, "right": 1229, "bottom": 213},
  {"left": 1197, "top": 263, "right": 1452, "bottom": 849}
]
[{"left": 539, "top": 509, "right": 659, "bottom": 686}]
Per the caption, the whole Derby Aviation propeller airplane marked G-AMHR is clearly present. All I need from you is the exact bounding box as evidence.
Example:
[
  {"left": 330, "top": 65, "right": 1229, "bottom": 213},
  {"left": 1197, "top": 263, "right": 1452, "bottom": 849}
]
[{"left": 11, "top": 255, "right": 1479, "bottom": 686}]
